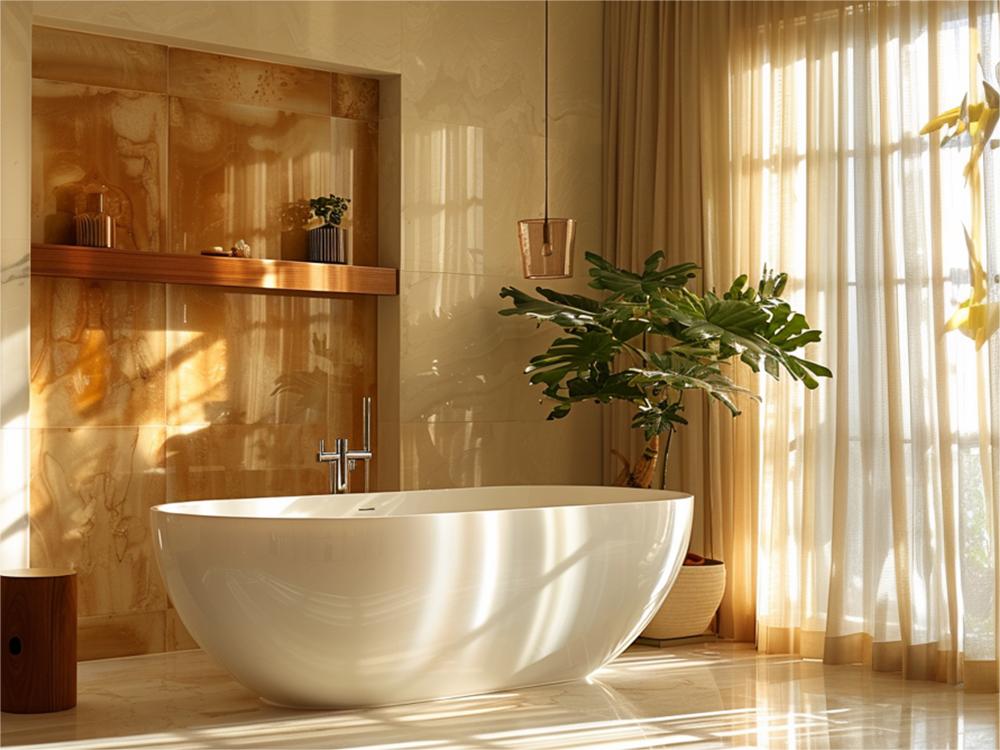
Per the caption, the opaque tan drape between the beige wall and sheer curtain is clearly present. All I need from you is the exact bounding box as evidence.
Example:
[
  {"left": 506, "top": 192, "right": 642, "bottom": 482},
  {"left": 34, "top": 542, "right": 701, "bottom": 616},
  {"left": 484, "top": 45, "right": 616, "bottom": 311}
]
[{"left": 604, "top": 3, "right": 758, "bottom": 641}]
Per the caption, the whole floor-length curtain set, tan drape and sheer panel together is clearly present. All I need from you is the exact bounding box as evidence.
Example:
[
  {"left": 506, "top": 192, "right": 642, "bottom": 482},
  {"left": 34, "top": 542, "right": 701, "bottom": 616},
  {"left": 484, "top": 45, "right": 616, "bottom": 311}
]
[{"left": 605, "top": 0, "right": 1000, "bottom": 690}]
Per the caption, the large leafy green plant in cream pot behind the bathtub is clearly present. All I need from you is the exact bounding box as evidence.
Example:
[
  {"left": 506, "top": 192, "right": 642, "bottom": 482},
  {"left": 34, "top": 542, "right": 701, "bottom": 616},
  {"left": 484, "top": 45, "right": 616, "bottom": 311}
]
[{"left": 500, "top": 252, "right": 832, "bottom": 639}]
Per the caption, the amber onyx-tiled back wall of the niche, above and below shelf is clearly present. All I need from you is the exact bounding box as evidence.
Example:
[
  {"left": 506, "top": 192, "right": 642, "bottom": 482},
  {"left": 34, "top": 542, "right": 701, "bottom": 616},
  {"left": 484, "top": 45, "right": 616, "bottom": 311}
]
[{"left": 30, "top": 27, "right": 379, "bottom": 659}]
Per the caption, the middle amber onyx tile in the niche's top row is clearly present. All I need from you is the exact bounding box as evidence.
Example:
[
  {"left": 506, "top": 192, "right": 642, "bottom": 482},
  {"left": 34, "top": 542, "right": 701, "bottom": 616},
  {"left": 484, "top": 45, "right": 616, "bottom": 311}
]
[{"left": 170, "top": 47, "right": 332, "bottom": 115}]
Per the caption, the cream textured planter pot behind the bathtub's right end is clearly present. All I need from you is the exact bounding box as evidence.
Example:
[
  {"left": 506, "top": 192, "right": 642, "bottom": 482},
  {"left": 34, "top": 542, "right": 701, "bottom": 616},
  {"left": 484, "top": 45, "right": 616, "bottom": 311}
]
[{"left": 642, "top": 560, "right": 726, "bottom": 640}]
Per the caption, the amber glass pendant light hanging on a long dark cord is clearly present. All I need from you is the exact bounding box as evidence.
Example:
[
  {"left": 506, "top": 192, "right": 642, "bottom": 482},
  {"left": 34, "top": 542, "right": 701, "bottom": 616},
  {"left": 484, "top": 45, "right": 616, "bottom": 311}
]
[{"left": 517, "top": 0, "right": 576, "bottom": 279}]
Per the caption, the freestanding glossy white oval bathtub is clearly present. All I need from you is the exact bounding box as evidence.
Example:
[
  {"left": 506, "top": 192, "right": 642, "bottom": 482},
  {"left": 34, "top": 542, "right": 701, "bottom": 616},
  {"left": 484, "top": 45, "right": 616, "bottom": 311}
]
[{"left": 152, "top": 487, "right": 692, "bottom": 708}]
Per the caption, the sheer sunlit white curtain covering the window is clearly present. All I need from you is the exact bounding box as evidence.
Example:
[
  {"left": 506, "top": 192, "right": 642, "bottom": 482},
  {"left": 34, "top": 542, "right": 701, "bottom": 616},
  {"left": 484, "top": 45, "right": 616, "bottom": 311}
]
[{"left": 752, "top": 3, "right": 1000, "bottom": 681}]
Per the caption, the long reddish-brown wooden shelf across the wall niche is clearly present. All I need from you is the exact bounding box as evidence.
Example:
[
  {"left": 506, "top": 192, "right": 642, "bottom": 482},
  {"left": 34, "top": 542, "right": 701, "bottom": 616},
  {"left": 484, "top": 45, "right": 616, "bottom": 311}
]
[{"left": 31, "top": 245, "right": 399, "bottom": 296}]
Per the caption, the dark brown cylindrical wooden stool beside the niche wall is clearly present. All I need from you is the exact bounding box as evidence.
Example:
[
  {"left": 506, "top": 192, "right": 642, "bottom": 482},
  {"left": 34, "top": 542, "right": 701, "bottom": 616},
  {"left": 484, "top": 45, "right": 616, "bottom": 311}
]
[{"left": 0, "top": 568, "right": 76, "bottom": 714}]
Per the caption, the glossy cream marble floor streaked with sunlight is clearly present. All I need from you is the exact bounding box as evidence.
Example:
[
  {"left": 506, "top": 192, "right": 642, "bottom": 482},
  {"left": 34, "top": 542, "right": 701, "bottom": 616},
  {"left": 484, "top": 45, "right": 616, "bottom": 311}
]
[{"left": 0, "top": 643, "right": 998, "bottom": 750}]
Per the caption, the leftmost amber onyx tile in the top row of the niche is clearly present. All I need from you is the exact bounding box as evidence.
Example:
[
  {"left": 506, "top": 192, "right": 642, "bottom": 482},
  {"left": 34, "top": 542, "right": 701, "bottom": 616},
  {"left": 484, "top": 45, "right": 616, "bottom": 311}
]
[{"left": 31, "top": 26, "right": 167, "bottom": 94}]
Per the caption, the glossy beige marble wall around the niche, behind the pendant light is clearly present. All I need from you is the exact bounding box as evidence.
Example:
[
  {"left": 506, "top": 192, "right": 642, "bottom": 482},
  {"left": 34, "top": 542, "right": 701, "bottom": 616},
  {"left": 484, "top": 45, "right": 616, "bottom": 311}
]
[{"left": 15, "top": 2, "right": 602, "bottom": 648}]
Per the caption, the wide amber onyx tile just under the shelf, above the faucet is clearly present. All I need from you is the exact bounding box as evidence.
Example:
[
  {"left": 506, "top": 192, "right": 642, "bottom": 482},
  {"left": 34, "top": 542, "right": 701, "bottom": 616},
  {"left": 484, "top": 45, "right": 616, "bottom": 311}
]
[{"left": 166, "top": 286, "right": 377, "bottom": 428}]
